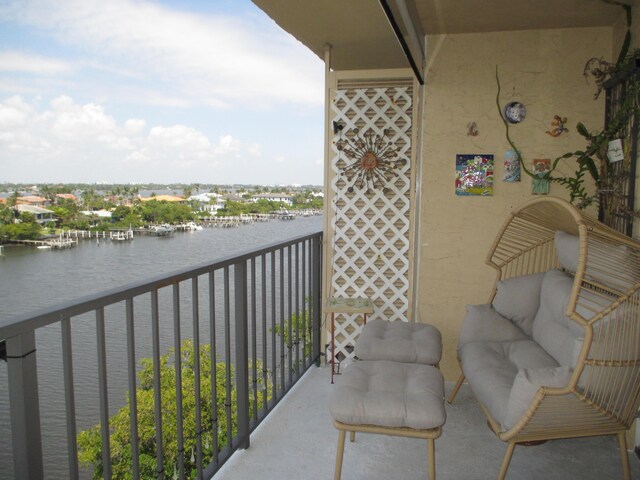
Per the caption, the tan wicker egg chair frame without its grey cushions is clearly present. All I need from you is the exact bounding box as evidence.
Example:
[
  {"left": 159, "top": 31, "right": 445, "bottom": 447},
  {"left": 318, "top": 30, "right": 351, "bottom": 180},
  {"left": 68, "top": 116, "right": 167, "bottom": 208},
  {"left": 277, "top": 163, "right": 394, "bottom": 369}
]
[{"left": 449, "top": 197, "right": 640, "bottom": 480}]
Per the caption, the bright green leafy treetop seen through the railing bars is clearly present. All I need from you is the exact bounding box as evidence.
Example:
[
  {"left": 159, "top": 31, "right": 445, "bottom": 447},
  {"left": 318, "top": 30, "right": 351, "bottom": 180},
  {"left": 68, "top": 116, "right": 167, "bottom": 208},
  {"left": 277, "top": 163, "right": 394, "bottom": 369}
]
[{"left": 78, "top": 340, "right": 271, "bottom": 479}]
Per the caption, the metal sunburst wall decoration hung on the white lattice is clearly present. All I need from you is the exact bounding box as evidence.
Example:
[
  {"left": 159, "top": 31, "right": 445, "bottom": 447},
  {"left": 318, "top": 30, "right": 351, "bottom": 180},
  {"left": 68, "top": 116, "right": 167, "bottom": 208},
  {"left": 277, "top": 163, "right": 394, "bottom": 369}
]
[{"left": 336, "top": 125, "right": 407, "bottom": 193}]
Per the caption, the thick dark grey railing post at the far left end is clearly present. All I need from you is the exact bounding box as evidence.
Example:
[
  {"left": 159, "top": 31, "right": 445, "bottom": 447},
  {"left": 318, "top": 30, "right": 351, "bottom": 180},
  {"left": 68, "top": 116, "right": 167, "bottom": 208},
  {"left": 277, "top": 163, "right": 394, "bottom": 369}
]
[{"left": 6, "top": 330, "right": 43, "bottom": 480}]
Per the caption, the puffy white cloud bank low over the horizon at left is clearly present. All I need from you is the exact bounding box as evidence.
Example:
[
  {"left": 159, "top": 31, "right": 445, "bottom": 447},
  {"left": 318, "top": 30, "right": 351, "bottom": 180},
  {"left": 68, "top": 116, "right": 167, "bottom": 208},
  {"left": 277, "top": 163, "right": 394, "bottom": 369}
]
[{"left": 0, "top": 96, "right": 261, "bottom": 182}]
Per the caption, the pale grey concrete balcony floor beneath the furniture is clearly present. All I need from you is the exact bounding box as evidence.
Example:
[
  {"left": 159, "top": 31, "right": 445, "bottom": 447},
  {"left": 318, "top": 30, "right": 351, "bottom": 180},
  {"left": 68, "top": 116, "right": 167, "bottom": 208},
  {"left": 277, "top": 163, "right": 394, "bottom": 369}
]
[{"left": 214, "top": 367, "right": 640, "bottom": 480}]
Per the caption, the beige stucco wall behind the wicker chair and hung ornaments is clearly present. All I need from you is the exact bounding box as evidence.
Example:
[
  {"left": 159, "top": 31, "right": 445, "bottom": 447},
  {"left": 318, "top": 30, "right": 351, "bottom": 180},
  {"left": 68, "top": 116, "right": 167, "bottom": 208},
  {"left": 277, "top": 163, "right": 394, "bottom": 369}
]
[{"left": 417, "top": 28, "right": 613, "bottom": 380}]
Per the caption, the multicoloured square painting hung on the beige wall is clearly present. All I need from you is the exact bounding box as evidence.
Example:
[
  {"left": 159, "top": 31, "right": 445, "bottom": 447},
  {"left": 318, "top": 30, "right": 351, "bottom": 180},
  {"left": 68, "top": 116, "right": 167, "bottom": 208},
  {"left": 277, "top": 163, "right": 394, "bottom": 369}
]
[{"left": 456, "top": 153, "right": 493, "bottom": 196}]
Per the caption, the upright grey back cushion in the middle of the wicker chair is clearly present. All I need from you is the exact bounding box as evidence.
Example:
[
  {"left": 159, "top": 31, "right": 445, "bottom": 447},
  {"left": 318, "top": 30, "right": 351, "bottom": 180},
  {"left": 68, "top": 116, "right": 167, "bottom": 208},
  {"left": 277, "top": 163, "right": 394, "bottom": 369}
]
[{"left": 532, "top": 270, "right": 583, "bottom": 368}]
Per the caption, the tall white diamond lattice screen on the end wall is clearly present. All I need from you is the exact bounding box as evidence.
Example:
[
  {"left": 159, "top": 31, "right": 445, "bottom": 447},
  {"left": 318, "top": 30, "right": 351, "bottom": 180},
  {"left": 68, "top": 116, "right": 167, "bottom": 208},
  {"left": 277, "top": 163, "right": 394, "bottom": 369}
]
[{"left": 328, "top": 79, "right": 414, "bottom": 357}]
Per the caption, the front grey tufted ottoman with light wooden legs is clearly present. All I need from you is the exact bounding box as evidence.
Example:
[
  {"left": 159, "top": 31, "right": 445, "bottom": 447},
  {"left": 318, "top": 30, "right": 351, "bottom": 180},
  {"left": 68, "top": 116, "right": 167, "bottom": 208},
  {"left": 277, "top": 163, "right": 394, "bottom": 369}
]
[{"left": 329, "top": 360, "right": 446, "bottom": 480}]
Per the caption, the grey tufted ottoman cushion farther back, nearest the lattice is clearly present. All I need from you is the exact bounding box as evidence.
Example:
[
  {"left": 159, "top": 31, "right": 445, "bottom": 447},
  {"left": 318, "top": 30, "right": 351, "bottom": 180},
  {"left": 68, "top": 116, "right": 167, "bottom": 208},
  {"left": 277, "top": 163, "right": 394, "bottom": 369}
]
[{"left": 355, "top": 319, "right": 442, "bottom": 366}]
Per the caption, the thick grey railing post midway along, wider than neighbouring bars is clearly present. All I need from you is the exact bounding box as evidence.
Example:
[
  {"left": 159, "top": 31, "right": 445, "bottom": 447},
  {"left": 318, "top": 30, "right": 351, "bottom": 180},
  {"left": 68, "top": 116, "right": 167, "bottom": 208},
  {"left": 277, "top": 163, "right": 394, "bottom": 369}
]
[{"left": 233, "top": 260, "right": 249, "bottom": 449}]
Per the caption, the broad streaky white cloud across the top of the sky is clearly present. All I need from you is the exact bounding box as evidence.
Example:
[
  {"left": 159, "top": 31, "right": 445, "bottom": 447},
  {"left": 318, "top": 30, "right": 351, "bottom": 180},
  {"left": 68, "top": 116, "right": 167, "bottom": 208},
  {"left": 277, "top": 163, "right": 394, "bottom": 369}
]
[{"left": 0, "top": 0, "right": 323, "bottom": 108}]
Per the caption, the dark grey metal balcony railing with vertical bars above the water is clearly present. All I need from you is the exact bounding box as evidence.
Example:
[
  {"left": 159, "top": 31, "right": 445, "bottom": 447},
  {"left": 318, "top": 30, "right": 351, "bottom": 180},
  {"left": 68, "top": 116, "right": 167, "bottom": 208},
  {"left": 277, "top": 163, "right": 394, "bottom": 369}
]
[{"left": 0, "top": 232, "right": 322, "bottom": 479}]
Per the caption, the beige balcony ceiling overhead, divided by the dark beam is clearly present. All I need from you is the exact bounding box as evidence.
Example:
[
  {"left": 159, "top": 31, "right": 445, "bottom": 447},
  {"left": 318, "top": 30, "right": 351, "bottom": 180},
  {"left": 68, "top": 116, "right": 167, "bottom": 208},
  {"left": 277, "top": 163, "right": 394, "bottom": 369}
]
[{"left": 253, "top": 0, "right": 636, "bottom": 70}]
